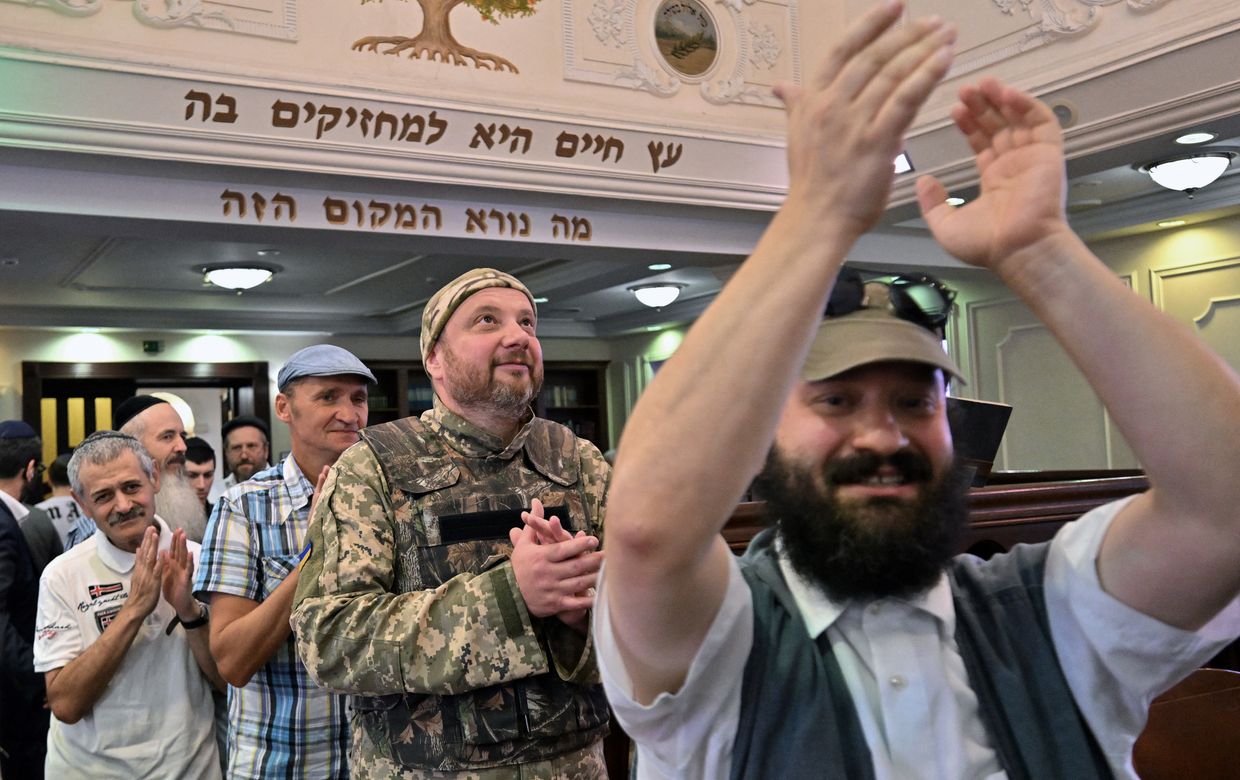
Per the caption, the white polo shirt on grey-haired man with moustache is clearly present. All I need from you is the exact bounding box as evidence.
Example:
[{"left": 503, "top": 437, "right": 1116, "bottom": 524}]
[{"left": 35, "top": 517, "right": 219, "bottom": 780}]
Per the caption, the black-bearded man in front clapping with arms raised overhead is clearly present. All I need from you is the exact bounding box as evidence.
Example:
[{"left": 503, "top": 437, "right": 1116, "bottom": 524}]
[{"left": 595, "top": 2, "right": 1240, "bottom": 779}]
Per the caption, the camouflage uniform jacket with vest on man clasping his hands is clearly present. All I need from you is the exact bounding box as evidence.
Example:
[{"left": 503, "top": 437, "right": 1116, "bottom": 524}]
[{"left": 291, "top": 404, "right": 608, "bottom": 771}]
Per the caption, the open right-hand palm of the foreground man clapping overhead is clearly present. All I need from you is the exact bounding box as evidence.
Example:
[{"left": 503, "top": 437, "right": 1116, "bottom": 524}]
[{"left": 918, "top": 78, "right": 1070, "bottom": 272}]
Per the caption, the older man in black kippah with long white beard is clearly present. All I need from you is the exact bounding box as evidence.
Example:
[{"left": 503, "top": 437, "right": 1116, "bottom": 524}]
[{"left": 64, "top": 396, "right": 207, "bottom": 549}]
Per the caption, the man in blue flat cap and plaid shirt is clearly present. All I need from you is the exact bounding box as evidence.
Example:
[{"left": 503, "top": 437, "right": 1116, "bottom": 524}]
[{"left": 195, "top": 343, "right": 374, "bottom": 780}]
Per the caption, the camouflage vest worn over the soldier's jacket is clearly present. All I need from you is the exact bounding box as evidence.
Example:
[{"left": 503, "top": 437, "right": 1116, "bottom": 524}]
[{"left": 353, "top": 418, "right": 608, "bottom": 771}]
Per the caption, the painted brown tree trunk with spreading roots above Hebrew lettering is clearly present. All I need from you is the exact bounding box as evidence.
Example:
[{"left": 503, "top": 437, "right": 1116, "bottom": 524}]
[{"left": 353, "top": 0, "right": 538, "bottom": 73}]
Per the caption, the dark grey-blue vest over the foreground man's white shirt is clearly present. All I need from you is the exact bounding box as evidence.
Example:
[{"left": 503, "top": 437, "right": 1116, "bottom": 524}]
[{"left": 732, "top": 528, "right": 1112, "bottom": 780}]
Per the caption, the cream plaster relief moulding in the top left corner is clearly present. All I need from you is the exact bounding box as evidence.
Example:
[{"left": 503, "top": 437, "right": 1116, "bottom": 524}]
[{"left": 0, "top": 0, "right": 298, "bottom": 41}]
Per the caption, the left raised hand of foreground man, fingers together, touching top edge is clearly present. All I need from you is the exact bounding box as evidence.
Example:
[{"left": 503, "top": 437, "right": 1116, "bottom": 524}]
[{"left": 775, "top": 1, "right": 956, "bottom": 238}]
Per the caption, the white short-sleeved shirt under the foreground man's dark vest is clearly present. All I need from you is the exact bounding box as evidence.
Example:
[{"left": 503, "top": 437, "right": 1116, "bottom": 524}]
[{"left": 594, "top": 499, "right": 1240, "bottom": 780}]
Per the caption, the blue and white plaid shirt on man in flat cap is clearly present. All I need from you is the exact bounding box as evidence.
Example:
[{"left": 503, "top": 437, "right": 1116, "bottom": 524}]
[{"left": 193, "top": 455, "right": 348, "bottom": 778}]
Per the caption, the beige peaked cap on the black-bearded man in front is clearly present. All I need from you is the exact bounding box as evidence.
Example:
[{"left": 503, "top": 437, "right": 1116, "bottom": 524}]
[{"left": 801, "top": 281, "right": 963, "bottom": 382}]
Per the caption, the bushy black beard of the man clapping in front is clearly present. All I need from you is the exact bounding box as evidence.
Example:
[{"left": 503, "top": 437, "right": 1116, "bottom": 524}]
[{"left": 754, "top": 449, "right": 968, "bottom": 601}]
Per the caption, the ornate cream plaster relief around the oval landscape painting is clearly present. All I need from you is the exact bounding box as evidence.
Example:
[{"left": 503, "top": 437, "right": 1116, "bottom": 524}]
[{"left": 560, "top": 0, "right": 801, "bottom": 108}]
